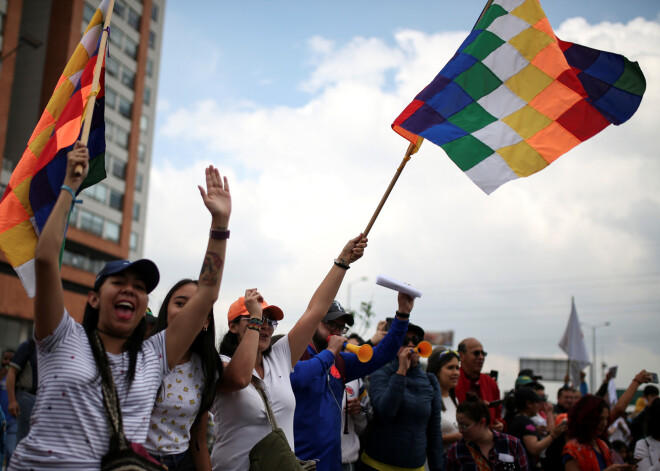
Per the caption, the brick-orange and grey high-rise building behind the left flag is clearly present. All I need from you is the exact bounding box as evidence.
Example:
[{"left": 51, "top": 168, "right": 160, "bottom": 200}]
[{"left": 0, "top": 0, "right": 165, "bottom": 348}]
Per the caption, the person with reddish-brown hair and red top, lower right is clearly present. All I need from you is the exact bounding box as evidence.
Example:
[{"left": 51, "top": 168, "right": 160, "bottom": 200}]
[{"left": 563, "top": 394, "right": 632, "bottom": 471}]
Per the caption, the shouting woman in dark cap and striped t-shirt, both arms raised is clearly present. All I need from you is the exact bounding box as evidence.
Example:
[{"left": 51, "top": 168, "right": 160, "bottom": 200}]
[{"left": 9, "top": 142, "right": 231, "bottom": 471}]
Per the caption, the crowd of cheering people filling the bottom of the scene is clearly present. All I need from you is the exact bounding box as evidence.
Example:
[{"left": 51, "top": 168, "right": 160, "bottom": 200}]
[{"left": 0, "top": 143, "right": 660, "bottom": 471}]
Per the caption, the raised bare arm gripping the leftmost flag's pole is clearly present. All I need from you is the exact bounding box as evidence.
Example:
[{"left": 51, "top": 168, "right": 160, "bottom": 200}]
[{"left": 34, "top": 142, "right": 89, "bottom": 340}]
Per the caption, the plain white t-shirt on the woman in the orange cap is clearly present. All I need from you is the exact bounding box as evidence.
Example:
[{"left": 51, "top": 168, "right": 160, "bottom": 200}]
[{"left": 211, "top": 336, "right": 296, "bottom": 471}]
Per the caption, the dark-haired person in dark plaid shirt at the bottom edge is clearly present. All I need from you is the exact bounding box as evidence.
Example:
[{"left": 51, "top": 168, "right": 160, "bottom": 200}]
[{"left": 446, "top": 396, "right": 529, "bottom": 471}]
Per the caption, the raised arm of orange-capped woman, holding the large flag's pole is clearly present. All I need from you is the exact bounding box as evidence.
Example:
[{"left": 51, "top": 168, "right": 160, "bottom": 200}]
[{"left": 289, "top": 234, "right": 367, "bottom": 366}]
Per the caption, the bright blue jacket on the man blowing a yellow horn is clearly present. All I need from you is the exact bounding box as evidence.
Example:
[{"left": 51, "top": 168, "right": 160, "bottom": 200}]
[{"left": 291, "top": 318, "right": 408, "bottom": 471}]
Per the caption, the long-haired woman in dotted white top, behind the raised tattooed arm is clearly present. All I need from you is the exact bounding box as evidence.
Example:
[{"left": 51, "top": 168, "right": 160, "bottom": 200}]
[{"left": 144, "top": 279, "right": 222, "bottom": 471}]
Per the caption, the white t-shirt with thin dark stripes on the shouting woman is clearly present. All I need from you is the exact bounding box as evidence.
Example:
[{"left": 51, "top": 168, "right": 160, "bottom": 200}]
[{"left": 9, "top": 311, "right": 168, "bottom": 470}]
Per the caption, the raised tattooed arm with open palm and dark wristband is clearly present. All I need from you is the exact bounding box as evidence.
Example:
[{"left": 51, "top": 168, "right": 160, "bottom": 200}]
[{"left": 165, "top": 165, "right": 231, "bottom": 368}]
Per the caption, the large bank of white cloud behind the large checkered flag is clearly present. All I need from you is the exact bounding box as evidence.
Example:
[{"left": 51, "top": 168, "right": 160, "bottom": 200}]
[{"left": 150, "top": 18, "right": 660, "bottom": 389}]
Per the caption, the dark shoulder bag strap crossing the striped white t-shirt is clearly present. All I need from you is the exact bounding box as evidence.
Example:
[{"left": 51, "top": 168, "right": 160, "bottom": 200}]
[{"left": 89, "top": 331, "right": 128, "bottom": 450}]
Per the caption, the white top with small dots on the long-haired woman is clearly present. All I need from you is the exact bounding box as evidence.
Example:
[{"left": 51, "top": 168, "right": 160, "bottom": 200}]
[{"left": 144, "top": 353, "right": 205, "bottom": 455}]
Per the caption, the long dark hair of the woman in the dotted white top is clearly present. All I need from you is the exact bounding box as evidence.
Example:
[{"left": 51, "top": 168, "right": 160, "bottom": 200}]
[{"left": 152, "top": 278, "right": 222, "bottom": 421}]
